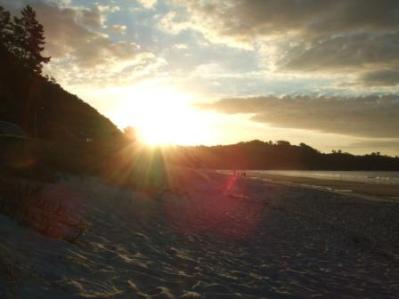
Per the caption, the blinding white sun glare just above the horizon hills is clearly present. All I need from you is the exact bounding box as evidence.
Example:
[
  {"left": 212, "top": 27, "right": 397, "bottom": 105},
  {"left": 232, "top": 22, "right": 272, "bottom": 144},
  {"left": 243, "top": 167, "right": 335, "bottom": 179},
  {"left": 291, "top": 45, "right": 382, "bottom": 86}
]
[{"left": 113, "top": 83, "right": 212, "bottom": 145}]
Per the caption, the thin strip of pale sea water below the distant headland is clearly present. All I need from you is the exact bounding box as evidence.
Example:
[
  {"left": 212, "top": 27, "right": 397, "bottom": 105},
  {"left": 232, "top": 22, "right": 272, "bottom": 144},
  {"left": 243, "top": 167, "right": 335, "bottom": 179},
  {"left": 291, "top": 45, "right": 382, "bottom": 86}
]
[{"left": 246, "top": 170, "right": 399, "bottom": 185}]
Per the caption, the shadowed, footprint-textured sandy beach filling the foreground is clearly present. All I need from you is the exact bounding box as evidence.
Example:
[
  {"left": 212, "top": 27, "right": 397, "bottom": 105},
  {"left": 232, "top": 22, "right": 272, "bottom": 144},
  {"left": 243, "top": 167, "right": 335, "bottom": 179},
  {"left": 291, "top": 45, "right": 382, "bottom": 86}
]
[{"left": 0, "top": 170, "right": 399, "bottom": 299}]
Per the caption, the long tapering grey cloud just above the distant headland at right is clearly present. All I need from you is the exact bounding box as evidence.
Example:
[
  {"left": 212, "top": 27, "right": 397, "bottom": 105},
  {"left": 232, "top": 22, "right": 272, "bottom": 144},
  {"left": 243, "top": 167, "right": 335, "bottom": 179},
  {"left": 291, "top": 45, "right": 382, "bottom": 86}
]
[{"left": 198, "top": 95, "right": 399, "bottom": 138}]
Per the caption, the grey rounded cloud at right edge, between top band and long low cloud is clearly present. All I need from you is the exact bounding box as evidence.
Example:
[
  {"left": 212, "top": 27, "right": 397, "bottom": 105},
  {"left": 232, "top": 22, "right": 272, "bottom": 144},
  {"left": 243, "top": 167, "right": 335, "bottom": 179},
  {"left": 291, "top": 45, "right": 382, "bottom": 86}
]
[{"left": 280, "top": 32, "right": 399, "bottom": 72}]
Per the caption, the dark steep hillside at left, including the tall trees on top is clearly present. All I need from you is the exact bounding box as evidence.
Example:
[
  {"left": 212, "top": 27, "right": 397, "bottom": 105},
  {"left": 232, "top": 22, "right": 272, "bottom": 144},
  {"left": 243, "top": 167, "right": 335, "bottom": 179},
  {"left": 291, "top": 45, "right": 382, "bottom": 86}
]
[{"left": 0, "top": 5, "right": 123, "bottom": 178}]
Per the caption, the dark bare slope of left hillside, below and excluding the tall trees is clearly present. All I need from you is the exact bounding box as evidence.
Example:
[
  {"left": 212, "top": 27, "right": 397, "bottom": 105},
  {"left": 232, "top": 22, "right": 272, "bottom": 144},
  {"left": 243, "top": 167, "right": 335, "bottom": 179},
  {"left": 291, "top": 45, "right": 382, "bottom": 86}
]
[{"left": 0, "top": 48, "right": 120, "bottom": 142}]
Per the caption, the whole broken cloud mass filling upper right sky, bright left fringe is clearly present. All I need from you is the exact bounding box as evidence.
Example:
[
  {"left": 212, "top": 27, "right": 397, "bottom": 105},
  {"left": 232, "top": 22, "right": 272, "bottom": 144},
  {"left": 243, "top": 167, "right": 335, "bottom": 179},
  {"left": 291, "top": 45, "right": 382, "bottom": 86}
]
[{"left": 168, "top": 0, "right": 399, "bottom": 86}]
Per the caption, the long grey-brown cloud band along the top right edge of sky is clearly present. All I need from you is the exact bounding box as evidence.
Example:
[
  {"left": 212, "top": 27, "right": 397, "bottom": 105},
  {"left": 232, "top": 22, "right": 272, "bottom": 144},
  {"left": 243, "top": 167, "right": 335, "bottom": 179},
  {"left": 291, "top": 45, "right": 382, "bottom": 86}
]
[{"left": 177, "top": 0, "right": 399, "bottom": 39}]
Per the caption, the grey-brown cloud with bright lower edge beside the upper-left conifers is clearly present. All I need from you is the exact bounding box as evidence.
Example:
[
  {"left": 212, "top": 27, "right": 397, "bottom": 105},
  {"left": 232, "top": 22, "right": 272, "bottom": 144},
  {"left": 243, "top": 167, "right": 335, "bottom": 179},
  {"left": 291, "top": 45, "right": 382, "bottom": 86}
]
[{"left": 0, "top": 0, "right": 164, "bottom": 84}]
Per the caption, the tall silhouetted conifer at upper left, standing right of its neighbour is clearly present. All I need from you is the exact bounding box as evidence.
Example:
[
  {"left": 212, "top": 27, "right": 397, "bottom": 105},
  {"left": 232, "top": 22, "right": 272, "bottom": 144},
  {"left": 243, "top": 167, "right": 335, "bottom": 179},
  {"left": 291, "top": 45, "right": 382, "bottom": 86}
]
[{"left": 11, "top": 5, "right": 50, "bottom": 74}]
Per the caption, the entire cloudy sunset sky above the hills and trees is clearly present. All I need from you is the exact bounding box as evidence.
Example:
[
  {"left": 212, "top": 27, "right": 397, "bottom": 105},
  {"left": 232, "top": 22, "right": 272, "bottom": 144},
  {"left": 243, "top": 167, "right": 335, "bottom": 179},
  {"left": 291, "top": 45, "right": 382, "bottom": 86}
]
[{"left": 0, "top": 0, "right": 399, "bottom": 155}]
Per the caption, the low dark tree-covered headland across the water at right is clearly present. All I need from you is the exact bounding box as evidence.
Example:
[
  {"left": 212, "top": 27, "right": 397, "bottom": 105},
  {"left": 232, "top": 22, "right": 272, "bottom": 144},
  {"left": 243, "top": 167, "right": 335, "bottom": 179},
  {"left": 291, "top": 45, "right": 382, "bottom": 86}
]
[{"left": 174, "top": 140, "right": 399, "bottom": 170}]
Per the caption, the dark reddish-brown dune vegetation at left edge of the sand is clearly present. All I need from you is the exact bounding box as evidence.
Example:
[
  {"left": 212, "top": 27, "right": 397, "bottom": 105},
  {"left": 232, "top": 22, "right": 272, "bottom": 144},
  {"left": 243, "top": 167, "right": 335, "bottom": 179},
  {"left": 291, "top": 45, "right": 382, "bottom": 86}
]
[{"left": 0, "top": 178, "right": 87, "bottom": 242}]
